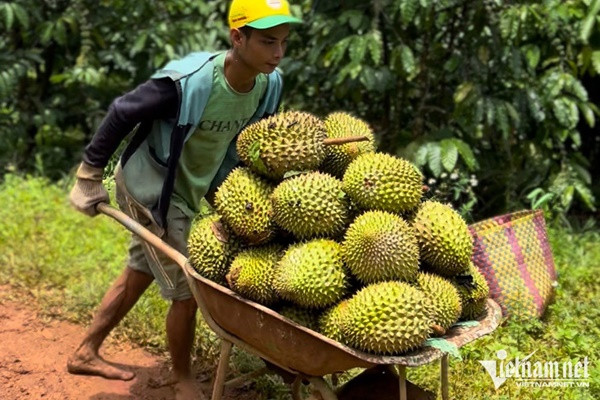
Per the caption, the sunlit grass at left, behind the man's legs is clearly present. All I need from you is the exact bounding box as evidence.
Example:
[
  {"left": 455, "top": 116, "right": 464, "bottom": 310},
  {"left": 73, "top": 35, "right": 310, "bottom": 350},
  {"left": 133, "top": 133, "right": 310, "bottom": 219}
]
[{"left": 0, "top": 175, "right": 172, "bottom": 349}]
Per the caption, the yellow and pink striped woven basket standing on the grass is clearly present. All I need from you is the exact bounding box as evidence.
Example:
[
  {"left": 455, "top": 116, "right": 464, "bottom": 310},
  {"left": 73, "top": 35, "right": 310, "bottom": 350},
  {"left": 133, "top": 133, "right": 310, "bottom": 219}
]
[{"left": 469, "top": 210, "right": 556, "bottom": 318}]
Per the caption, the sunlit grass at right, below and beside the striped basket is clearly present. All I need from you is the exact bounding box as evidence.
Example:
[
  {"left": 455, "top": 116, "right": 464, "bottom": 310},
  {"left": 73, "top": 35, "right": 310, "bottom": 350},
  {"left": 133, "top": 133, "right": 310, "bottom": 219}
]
[{"left": 408, "top": 223, "right": 600, "bottom": 400}]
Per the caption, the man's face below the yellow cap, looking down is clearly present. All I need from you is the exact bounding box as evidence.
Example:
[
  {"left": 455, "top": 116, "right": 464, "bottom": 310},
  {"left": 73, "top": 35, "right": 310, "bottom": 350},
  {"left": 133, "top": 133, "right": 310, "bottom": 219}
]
[{"left": 234, "top": 24, "right": 290, "bottom": 74}]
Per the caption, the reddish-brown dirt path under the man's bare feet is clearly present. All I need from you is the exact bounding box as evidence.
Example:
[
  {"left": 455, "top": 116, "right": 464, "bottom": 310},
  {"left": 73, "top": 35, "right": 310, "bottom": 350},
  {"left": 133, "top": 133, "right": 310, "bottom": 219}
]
[{"left": 0, "top": 287, "right": 255, "bottom": 400}]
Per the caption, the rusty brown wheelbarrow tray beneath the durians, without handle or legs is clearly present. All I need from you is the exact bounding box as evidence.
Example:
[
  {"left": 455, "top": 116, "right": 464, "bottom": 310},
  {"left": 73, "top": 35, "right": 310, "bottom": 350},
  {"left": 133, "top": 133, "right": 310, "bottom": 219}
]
[{"left": 186, "top": 264, "right": 502, "bottom": 376}]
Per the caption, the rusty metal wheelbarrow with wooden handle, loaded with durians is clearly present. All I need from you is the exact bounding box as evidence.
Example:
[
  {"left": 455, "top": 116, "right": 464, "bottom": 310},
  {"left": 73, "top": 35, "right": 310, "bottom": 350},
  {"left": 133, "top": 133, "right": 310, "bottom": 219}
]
[{"left": 97, "top": 203, "right": 502, "bottom": 400}]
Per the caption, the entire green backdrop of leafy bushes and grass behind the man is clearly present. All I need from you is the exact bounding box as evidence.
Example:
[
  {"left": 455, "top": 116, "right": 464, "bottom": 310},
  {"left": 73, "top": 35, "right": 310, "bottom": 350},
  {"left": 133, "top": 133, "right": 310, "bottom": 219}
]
[{"left": 0, "top": 0, "right": 600, "bottom": 399}]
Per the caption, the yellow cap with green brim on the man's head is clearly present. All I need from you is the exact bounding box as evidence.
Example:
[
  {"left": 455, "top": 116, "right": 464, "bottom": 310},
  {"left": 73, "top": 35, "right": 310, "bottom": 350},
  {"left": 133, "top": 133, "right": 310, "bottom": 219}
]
[{"left": 228, "top": 0, "right": 302, "bottom": 29}]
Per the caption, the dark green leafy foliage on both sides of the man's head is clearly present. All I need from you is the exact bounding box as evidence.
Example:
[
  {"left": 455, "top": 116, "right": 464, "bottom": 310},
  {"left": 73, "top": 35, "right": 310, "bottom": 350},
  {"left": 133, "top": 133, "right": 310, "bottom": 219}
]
[{"left": 0, "top": 0, "right": 600, "bottom": 219}]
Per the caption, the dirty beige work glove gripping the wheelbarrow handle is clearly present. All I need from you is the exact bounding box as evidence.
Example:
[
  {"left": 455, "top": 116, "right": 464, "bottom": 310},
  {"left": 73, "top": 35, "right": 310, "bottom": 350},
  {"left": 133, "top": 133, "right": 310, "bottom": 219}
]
[{"left": 69, "top": 162, "right": 110, "bottom": 217}]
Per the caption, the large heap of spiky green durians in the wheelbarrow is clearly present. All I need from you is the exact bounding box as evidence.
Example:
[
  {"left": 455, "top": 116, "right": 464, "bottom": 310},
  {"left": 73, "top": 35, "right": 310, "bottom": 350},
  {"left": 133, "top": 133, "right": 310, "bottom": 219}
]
[{"left": 188, "top": 111, "right": 489, "bottom": 355}]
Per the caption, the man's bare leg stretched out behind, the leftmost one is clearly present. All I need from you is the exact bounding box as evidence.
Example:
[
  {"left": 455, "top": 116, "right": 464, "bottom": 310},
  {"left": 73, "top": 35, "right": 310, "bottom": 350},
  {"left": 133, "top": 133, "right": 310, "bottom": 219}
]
[{"left": 67, "top": 267, "right": 154, "bottom": 380}]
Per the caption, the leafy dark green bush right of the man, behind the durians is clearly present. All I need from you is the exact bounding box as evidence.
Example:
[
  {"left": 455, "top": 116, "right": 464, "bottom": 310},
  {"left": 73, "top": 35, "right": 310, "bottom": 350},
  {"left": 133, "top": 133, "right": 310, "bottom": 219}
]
[{"left": 284, "top": 0, "right": 600, "bottom": 219}]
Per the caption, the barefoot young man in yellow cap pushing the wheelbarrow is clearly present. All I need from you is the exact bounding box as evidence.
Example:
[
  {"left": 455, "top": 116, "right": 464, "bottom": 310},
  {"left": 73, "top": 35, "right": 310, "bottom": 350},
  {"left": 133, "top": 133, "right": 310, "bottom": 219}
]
[{"left": 67, "top": 0, "right": 300, "bottom": 399}]
